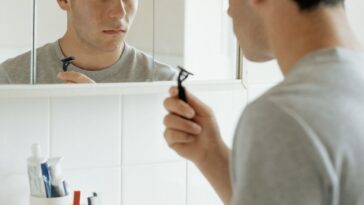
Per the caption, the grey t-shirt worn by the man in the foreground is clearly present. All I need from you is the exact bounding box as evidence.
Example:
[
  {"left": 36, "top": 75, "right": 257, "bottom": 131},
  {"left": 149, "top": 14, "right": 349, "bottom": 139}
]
[{"left": 231, "top": 48, "right": 364, "bottom": 205}]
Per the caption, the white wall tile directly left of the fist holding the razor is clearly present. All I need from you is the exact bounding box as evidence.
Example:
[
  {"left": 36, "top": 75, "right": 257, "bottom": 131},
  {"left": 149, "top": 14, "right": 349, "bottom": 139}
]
[{"left": 123, "top": 93, "right": 183, "bottom": 165}]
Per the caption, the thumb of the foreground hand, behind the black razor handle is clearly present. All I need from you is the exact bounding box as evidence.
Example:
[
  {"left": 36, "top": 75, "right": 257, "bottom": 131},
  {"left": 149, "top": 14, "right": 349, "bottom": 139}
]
[{"left": 169, "top": 86, "right": 212, "bottom": 117}]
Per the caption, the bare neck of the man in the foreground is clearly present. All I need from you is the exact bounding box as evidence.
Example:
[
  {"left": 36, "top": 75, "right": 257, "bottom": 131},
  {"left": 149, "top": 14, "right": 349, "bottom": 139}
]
[{"left": 268, "top": 7, "right": 362, "bottom": 75}]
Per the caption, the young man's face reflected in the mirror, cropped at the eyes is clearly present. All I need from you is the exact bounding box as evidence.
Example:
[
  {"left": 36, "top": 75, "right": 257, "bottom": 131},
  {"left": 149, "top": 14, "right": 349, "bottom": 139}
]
[{"left": 64, "top": 0, "right": 138, "bottom": 51}]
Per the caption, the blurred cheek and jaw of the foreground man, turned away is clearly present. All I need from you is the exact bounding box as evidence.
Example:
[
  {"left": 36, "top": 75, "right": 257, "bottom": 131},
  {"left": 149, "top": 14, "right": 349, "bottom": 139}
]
[{"left": 228, "top": 0, "right": 272, "bottom": 62}]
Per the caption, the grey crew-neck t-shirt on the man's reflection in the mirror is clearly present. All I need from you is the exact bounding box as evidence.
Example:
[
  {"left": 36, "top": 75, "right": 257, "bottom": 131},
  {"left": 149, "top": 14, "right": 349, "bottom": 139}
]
[{"left": 0, "top": 41, "right": 176, "bottom": 84}]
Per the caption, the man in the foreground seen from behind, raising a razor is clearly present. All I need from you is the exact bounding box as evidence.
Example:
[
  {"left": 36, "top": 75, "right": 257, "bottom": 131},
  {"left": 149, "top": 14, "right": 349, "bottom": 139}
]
[{"left": 164, "top": 0, "right": 364, "bottom": 205}]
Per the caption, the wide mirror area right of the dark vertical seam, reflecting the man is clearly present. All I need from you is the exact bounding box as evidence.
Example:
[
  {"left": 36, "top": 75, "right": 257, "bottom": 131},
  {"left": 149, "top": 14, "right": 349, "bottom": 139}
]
[{"left": 0, "top": 0, "right": 238, "bottom": 84}]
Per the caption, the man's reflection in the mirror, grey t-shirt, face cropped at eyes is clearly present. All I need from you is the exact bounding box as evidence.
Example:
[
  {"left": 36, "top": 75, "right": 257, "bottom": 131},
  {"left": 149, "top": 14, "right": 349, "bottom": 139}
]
[{"left": 0, "top": 0, "right": 175, "bottom": 83}]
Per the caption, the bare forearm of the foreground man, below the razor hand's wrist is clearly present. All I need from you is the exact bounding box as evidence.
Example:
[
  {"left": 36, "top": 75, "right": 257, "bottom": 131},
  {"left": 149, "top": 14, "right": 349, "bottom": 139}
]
[{"left": 195, "top": 144, "right": 232, "bottom": 205}]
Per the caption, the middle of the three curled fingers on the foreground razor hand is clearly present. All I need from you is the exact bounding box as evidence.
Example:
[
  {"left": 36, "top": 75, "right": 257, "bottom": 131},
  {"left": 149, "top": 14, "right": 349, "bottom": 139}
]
[{"left": 164, "top": 114, "right": 202, "bottom": 135}]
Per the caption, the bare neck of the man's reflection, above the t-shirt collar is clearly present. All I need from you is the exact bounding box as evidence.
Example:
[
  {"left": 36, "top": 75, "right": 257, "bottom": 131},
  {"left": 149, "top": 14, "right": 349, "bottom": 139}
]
[{"left": 59, "top": 33, "right": 125, "bottom": 71}]
